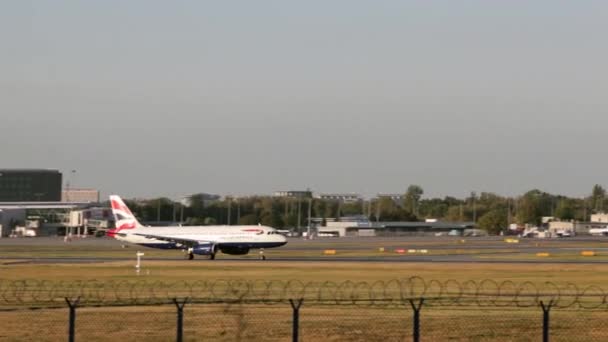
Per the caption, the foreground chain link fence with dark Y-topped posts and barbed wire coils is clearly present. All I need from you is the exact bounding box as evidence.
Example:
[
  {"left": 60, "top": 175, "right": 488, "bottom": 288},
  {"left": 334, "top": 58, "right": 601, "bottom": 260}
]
[{"left": 0, "top": 278, "right": 608, "bottom": 341}]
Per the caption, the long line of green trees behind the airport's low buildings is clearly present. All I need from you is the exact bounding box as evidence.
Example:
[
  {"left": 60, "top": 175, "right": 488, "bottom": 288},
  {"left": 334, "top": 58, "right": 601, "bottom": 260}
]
[{"left": 117, "top": 185, "right": 608, "bottom": 234}]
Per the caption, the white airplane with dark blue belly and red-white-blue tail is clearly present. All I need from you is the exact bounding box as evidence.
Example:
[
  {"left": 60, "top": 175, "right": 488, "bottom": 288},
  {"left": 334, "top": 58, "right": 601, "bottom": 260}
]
[{"left": 107, "top": 195, "right": 287, "bottom": 260}]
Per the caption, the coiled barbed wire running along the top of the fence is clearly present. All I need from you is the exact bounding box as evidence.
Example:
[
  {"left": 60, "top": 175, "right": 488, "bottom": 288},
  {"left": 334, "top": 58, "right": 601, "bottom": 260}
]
[{"left": 0, "top": 277, "right": 608, "bottom": 309}]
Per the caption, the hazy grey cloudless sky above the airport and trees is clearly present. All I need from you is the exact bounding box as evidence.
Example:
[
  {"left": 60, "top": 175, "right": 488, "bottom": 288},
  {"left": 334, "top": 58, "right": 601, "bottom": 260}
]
[{"left": 0, "top": 0, "right": 608, "bottom": 197}]
